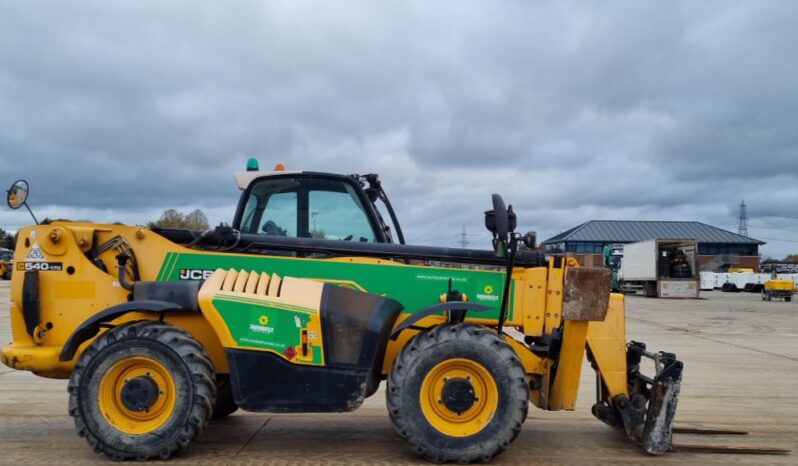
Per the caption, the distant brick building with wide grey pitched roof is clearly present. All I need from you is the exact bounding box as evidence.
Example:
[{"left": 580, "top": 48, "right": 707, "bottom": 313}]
[{"left": 541, "top": 220, "right": 765, "bottom": 271}]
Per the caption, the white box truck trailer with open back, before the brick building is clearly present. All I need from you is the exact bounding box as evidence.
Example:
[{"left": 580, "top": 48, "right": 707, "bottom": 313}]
[{"left": 618, "top": 239, "right": 700, "bottom": 298}]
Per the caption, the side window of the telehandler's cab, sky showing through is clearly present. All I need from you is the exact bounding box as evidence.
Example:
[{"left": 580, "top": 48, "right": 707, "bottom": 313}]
[{"left": 239, "top": 177, "right": 377, "bottom": 242}]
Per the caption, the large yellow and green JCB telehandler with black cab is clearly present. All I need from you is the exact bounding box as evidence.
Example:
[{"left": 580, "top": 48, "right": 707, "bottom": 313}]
[{"left": 0, "top": 163, "right": 682, "bottom": 463}]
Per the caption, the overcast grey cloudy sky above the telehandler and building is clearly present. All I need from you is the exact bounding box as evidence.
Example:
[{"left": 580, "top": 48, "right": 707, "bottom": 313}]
[{"left": 0, "top": 1, "right": 798, "bottom": 258}]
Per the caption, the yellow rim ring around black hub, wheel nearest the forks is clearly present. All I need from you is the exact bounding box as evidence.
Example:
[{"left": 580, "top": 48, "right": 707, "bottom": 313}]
[{"left": 419, "top": 358, "right": 499, "bottom": 437}]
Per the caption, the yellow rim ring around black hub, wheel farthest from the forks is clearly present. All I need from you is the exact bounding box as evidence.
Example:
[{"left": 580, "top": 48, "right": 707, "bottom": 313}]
[{"left": 97, "top": 356, "right": 177, "bottom": 434}]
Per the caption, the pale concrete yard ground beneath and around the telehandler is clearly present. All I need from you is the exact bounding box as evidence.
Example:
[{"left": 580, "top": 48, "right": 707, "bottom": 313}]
[{"left": 0, "top": 281, "right": 798, "bottom": 465}]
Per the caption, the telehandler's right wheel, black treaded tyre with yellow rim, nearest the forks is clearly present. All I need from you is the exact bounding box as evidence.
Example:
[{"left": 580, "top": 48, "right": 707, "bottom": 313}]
[{"left": 386, "top": 324, "right": 529, "bottom": 463}]
